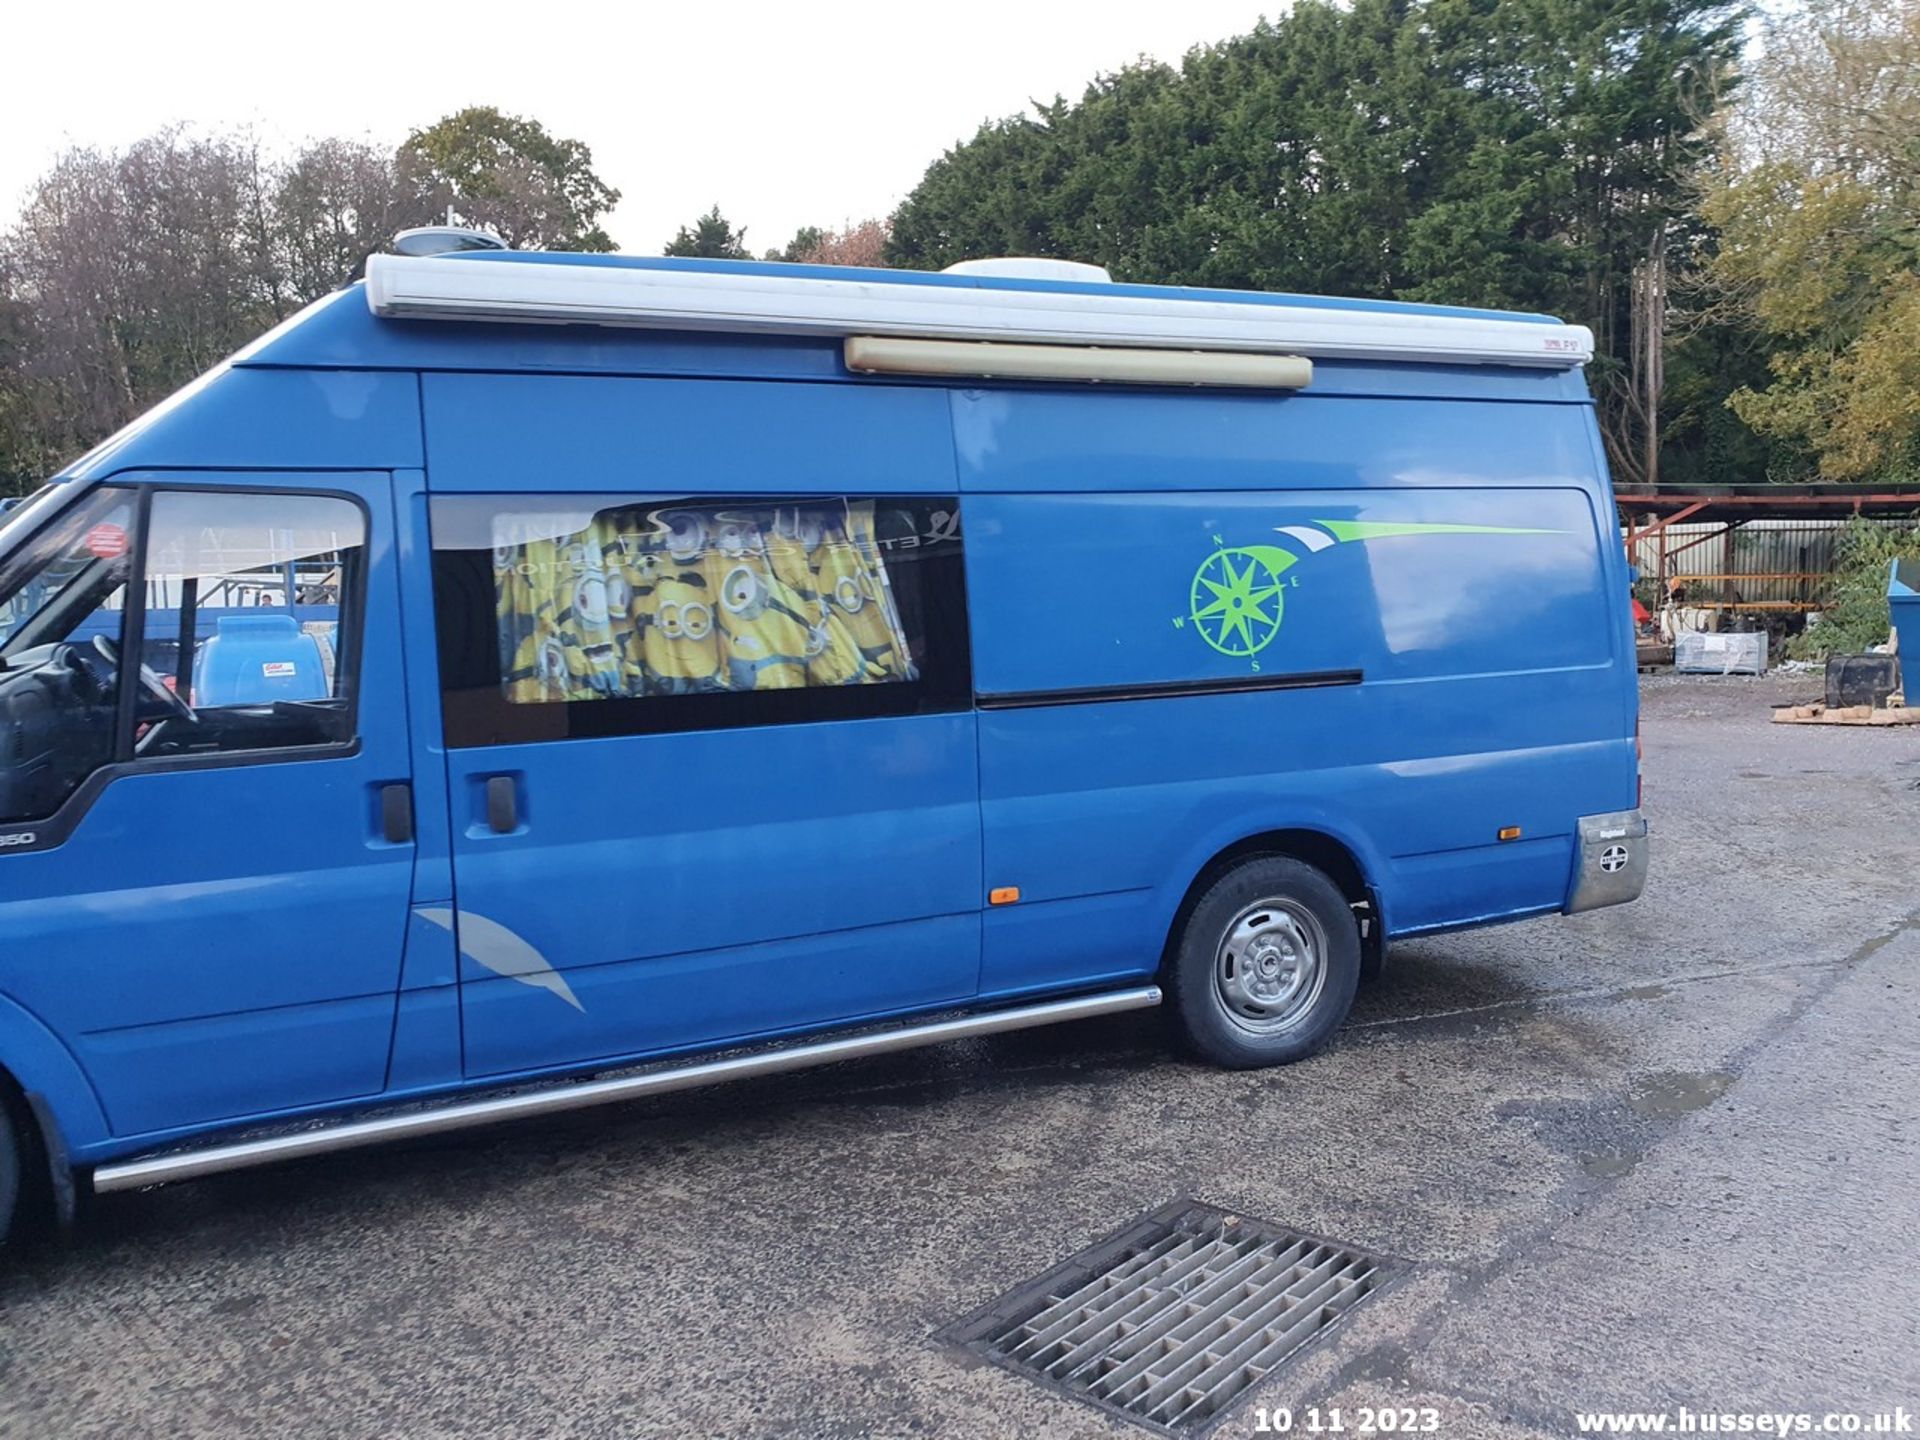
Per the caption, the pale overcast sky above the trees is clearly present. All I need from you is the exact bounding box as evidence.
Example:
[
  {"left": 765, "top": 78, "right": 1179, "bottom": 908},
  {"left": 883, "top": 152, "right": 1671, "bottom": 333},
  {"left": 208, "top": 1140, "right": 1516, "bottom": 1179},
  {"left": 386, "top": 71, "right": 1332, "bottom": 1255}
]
[{"left": 0, "top": 0, "right": 1283, "bottom": 252}]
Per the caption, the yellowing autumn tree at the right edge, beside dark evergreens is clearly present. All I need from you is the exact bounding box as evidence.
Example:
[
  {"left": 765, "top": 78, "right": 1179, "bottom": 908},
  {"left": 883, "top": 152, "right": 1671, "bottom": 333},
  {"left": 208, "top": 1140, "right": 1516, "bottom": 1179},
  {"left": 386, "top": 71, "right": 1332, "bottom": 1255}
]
[{"left": 1703, "top": 0, "right": 1920, "bottom": 480}]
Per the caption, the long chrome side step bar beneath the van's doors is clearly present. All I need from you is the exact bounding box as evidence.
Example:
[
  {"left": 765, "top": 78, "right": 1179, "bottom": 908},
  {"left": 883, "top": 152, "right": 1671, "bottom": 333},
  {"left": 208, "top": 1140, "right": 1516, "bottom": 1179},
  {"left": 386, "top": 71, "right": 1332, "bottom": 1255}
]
[{"left": 94, "top": 985, "right": 1160, "bottom": 1194}]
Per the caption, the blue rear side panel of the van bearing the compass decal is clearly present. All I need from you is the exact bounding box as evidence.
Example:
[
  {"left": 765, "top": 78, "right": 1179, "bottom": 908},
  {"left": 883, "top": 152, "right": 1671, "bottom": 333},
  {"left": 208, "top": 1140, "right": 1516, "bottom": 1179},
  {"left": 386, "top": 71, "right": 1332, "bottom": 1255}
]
[{"left": 954, "top": 392, "right": 1634, "bottom": 993}]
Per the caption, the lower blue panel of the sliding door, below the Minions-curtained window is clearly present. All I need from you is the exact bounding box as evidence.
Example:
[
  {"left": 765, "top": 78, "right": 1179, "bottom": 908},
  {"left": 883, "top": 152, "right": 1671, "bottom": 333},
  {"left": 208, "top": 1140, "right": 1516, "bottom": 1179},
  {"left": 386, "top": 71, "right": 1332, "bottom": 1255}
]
[{"left": 453, "top": 714, "right": 979, "bottom": 1075}]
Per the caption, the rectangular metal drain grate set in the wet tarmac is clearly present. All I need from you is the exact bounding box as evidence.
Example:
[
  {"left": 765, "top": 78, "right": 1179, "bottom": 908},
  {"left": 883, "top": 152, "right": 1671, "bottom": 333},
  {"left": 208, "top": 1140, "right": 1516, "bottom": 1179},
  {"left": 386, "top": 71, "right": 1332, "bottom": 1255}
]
[{"left": 943, "top": 1200, "right": 1396, "bottom": 1434}]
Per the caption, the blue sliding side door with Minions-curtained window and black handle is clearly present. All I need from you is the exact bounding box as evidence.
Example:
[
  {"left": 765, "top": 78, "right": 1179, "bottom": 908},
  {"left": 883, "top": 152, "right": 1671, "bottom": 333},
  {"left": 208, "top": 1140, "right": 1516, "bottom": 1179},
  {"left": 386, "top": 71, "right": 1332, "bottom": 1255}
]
[{"left": 426, "top": 376, "right": 981, "bottom": 1075}]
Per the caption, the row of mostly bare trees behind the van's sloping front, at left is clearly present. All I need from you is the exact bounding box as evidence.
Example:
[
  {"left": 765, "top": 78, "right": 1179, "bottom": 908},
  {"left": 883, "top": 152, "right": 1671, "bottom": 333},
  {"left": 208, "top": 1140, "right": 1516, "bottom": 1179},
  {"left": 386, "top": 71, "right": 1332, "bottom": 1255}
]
[{"left": 0, "top": 109, "right": 618, "bottom": 493}]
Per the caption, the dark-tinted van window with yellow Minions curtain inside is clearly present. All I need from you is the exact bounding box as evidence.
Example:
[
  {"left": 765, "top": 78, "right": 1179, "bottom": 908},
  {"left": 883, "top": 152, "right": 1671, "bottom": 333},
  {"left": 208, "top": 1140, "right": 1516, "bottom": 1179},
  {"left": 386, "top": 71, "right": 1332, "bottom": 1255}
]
[{"left": 432, "top": 495, "right": 972, "bottom": 745}]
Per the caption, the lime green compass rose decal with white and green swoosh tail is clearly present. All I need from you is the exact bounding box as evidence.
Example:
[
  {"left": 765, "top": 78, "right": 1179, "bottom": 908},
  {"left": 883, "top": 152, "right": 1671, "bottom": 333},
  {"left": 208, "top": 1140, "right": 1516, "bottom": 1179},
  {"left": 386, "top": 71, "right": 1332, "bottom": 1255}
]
[{"left": 1173, "top": 520, "right": 1561, "bottom": 670}]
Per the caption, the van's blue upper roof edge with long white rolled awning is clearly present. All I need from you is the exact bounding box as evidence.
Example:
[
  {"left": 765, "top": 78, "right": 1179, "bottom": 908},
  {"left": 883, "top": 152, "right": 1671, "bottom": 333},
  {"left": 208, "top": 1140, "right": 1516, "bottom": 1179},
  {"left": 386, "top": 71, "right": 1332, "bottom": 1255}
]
[{"left": 56, "top": 252, "right": 1597, "bottom": 491}]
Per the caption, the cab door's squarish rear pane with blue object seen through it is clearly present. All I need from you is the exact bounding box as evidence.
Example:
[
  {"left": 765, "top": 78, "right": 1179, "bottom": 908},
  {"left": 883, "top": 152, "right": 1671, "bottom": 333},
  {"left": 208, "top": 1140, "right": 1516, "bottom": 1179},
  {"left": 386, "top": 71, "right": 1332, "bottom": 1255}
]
[{"left": 134, "top": 490, "right": 367, "bottom": 756}]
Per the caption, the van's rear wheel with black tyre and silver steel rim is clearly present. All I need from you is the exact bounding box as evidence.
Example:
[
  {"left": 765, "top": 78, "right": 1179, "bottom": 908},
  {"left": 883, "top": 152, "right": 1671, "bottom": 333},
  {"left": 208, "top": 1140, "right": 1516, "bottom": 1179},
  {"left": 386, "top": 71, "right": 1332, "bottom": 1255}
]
[{"left": 1173, "top": 854, "right": 1359, "bottom": 1069}]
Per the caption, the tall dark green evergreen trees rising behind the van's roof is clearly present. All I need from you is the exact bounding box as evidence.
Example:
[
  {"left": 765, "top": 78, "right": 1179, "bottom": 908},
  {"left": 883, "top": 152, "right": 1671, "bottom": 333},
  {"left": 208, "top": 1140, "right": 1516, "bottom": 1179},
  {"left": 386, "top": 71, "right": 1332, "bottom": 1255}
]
[{"left": 889, "top": 0, "right": 1738, "bottom": 487}]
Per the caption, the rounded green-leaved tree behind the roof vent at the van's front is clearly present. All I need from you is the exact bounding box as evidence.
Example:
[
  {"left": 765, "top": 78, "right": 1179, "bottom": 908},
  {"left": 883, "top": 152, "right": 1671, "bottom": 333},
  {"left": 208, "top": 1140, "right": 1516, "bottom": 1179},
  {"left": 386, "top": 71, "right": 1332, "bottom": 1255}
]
[{"left": 397, "top": 106, "right": 620, "bottom": 252}]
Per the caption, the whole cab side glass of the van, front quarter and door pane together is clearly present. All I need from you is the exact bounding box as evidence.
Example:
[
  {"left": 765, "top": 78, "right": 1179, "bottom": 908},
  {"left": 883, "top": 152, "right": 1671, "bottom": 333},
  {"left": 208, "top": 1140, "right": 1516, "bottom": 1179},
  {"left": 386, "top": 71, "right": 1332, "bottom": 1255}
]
[{"left": 0, "top": 488, "right": 367, "bottom": 824}]
